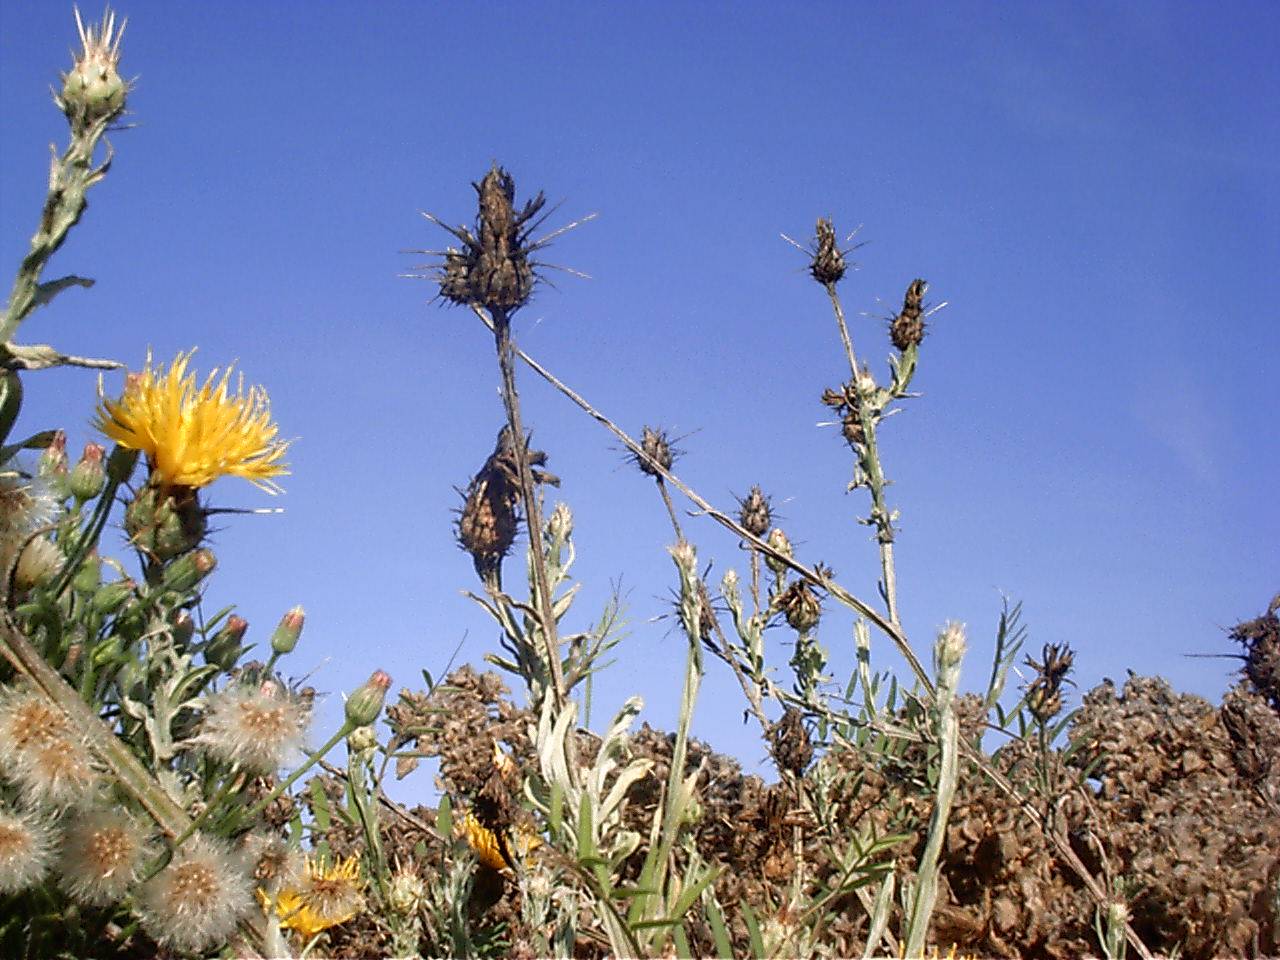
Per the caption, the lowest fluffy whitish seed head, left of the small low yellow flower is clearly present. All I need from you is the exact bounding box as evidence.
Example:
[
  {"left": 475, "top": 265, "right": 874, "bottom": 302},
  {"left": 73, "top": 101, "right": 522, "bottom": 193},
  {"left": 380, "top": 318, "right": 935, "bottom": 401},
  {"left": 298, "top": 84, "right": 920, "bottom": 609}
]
[{"left": 137, "top": 833, "right": 253, "bottom": 954}]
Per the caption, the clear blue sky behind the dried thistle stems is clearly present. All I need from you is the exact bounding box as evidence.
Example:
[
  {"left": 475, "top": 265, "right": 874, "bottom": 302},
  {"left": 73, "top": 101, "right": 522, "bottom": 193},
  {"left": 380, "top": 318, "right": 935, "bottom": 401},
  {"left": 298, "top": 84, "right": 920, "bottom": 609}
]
[{"left": 0, "top": 0, "right": 1280, "bottom": 788}]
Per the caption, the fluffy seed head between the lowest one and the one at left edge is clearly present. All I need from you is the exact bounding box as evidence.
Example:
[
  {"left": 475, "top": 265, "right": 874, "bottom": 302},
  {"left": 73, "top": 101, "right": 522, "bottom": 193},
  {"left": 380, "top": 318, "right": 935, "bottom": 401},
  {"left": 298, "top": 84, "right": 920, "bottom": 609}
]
[{"left": 58, "top": 810, "right": 147, "bottom": 906}]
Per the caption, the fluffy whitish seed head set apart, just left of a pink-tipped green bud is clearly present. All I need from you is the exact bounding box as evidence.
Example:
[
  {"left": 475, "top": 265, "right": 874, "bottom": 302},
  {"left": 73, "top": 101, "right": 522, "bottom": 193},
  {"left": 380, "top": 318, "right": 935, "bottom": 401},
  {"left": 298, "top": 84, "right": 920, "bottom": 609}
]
[{"left": 193, "top": 680, "right": 311, "bottom": 773}]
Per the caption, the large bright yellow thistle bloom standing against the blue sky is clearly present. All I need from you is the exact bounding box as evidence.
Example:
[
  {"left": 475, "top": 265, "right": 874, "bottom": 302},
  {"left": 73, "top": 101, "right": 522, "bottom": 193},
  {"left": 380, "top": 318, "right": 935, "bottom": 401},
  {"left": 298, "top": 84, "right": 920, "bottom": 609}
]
[{"left": 95, "top": 349, "right": 289, "bottom": 493}]
